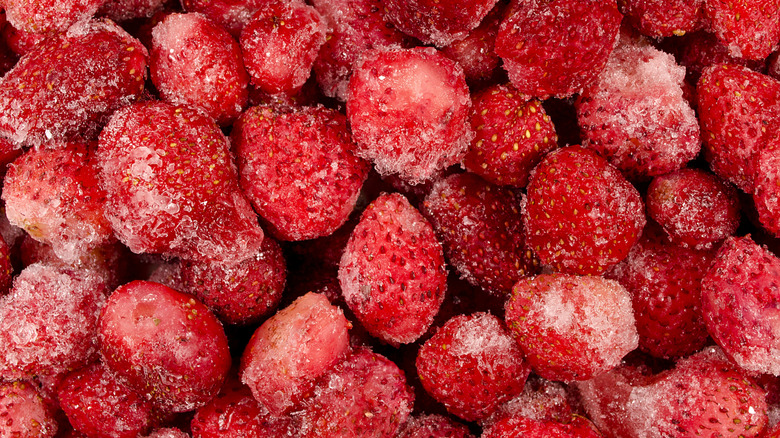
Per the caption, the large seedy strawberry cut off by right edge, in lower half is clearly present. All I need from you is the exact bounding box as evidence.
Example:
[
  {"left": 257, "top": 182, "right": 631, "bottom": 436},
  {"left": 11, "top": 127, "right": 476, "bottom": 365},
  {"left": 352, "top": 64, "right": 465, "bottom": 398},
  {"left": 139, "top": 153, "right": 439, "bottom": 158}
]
[{"left": 702, "top": 236, "right": 780, "bottom": 375}]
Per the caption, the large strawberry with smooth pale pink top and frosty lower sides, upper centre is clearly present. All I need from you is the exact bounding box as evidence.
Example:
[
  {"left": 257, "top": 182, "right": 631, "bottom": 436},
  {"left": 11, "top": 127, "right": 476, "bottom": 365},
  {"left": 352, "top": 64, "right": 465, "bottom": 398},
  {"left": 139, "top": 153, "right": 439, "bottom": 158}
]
[{"left": 347, "top": 47, "right": 474, "bottom": 184}]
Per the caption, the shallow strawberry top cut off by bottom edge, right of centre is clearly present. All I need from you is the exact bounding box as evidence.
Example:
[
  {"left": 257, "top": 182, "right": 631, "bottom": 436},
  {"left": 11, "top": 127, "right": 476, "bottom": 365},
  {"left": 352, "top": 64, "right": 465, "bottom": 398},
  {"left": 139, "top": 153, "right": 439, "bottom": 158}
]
[{"left": 482, "top": 416, "right": 602, "bottom": 438}]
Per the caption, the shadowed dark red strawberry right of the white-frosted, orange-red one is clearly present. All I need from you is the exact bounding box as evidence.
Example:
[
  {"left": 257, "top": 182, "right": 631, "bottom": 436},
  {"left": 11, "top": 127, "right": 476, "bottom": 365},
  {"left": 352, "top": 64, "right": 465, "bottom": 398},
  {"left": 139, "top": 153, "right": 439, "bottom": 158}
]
[{"left": 606, "top": 226, "right": 715, "bottom": 359}]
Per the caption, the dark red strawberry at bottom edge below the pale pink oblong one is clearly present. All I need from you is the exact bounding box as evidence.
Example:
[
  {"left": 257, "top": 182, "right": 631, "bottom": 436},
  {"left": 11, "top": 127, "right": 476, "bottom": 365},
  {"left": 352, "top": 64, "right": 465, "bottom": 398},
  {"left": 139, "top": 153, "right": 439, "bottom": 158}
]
[{"left": 190, "top": 378, "right": 297, "bottom": 438}]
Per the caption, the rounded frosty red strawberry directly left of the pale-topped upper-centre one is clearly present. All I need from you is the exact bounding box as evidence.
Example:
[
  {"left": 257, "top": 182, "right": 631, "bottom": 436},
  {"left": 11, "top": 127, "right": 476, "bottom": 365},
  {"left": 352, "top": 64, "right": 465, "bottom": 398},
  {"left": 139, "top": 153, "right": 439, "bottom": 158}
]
[{"left": 231, "top": 106, "right": 370, "bottom": 240}]
